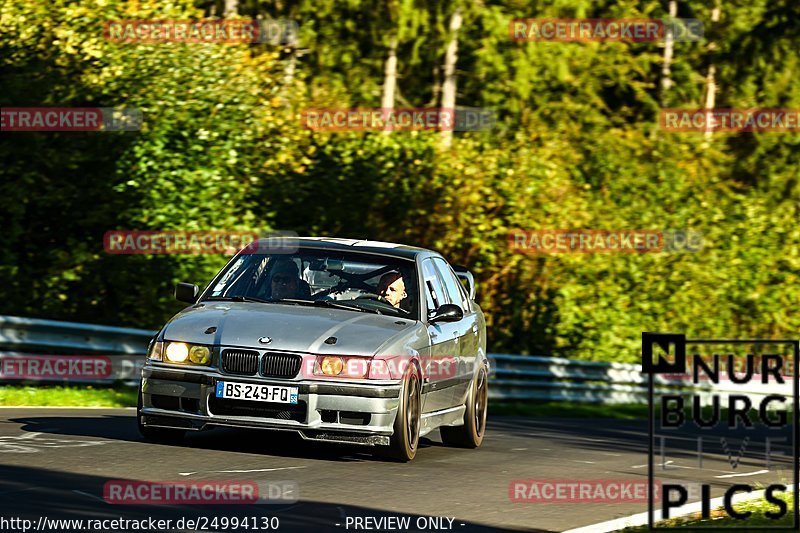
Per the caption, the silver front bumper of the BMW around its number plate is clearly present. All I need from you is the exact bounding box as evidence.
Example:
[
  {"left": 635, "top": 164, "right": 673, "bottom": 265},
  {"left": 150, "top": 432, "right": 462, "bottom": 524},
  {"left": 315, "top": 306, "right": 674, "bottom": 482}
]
[{"left": 141, "top": 365, "right": 401, "bottom": 445}]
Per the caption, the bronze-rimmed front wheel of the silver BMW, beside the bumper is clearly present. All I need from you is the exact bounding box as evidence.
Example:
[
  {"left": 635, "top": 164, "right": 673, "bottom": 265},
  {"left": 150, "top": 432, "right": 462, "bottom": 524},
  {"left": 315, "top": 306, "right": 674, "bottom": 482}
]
[{"left": 381, "top": 363, "right": 422, "bottom": 463}]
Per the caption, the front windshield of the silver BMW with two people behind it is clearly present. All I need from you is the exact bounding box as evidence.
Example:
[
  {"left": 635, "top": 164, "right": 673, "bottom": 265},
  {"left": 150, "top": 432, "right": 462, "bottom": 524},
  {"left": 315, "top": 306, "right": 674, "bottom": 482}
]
[{"left": 203, "top": 250, "right": 418, "bottom": 318}]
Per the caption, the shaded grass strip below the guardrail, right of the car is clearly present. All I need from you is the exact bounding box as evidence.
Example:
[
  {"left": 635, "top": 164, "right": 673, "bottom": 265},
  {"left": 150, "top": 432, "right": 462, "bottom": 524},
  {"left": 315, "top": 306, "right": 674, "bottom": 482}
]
[{"left": 489, "top": 400, "right": 647, "bottom": 419}]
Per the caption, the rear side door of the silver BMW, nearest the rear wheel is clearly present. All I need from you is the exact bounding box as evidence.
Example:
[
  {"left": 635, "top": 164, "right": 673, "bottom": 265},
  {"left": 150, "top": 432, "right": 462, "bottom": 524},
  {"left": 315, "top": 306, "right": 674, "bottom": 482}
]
[{"left": 433, "top": 257, "right": 479, "bottom": 405}]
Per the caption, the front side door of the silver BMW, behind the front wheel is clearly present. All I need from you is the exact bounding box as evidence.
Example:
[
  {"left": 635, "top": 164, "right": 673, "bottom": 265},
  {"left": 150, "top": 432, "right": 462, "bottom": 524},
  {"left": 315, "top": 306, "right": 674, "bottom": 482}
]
[{"left": 421, "top": 258, "right": 459, "bottom": 413}]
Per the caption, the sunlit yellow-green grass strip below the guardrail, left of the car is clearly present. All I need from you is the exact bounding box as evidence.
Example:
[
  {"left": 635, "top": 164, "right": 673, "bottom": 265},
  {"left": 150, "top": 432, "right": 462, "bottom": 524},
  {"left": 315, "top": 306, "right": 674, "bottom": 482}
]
[{"left": 0, "top": 385, "right": 137, "bottom": 407}]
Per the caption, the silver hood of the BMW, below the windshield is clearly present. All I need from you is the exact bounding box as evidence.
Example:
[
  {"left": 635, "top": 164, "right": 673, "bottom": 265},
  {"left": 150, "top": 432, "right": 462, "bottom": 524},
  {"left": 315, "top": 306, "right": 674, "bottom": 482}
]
[{"left": 163, "top": 302, "right": 417, "bottom": 355}]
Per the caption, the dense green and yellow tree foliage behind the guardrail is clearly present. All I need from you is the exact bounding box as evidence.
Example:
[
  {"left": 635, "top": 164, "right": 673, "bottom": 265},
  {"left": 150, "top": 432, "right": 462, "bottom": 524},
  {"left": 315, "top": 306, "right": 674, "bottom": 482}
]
[{"left": 0, "top": 0, "right": 800, "bottom": 361}]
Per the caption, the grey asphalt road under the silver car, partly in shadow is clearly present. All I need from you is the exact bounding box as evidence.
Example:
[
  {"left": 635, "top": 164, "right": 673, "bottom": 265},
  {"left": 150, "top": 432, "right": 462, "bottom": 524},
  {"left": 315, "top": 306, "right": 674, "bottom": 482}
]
[{"left": 0, "top": 407, "right": 786, "bottom": 531}]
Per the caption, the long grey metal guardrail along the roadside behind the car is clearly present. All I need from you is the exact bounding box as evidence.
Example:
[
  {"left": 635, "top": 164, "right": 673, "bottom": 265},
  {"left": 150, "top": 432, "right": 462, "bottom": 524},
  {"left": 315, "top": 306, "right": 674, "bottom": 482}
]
[{"left": 0, "top": 316, "right": 792, "bottom": 404}]
